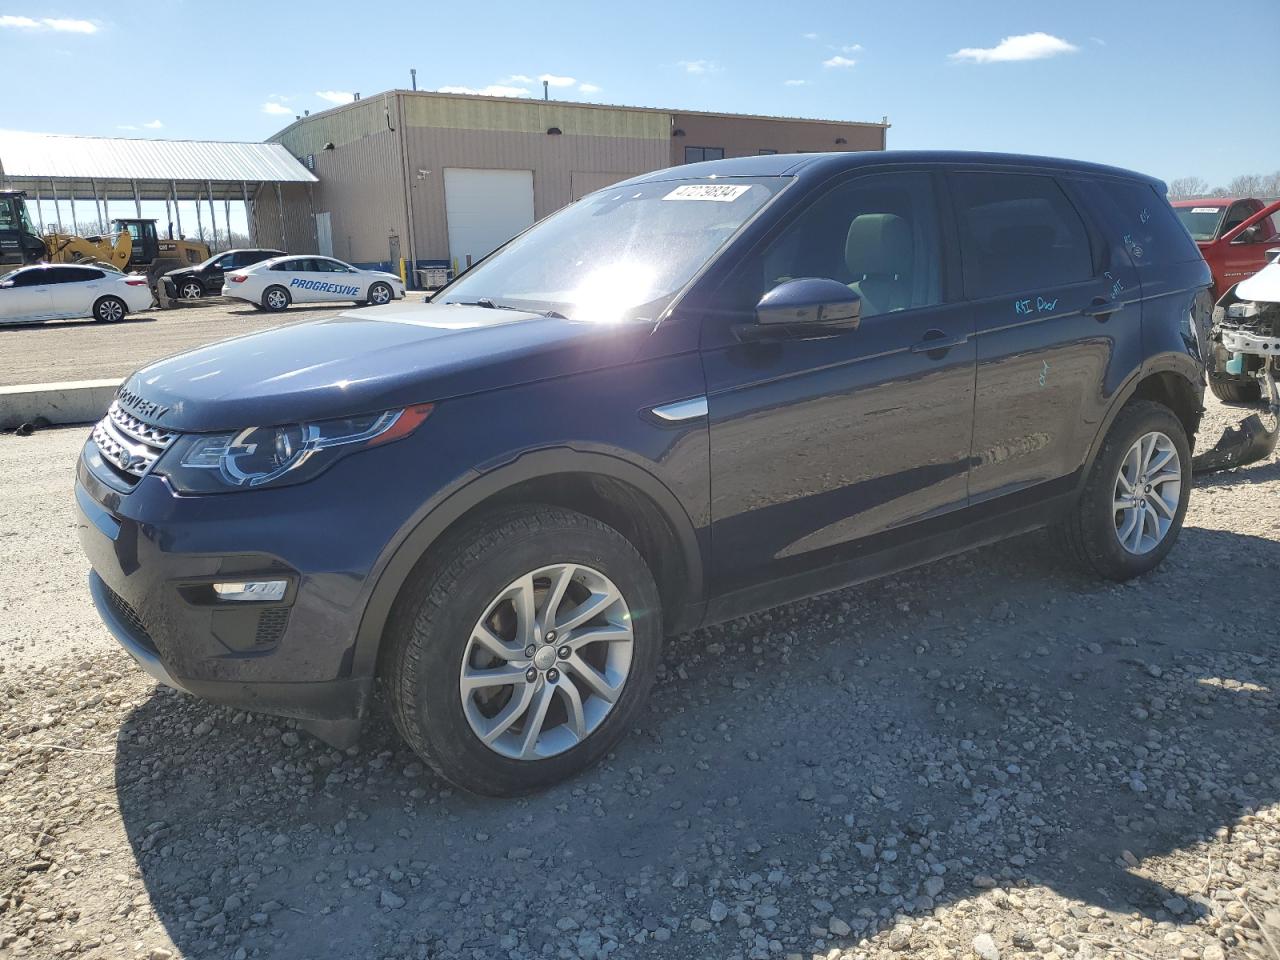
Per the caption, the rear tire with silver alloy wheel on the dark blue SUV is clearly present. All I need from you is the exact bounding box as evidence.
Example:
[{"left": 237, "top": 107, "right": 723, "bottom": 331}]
[{"left": 1056, "top": 399, "right": 1192, "bottom": 581}]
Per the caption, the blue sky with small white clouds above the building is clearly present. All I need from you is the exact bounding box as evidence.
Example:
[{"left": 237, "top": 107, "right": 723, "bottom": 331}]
[{"left": 0, "top": 0, "right": 1280, "bottom": 183}]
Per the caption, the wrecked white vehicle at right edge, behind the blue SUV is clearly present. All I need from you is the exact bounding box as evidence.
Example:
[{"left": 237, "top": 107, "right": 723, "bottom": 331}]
[{"left": 1196, "top": 250, "right": 1280, "bottom": 468}]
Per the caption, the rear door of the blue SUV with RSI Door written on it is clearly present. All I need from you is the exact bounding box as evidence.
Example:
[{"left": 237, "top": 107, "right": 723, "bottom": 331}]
[{"left": 947, "top": 170, "right": 1142, "bottom": 506}]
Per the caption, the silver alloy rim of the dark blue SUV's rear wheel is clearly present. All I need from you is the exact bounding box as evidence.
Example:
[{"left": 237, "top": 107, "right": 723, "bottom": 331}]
[{"left": 1112, "top": 431, "right": 1183, "bottom": 556}]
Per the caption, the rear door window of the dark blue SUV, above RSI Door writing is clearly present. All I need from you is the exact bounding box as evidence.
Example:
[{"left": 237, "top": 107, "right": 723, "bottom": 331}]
[{"left": 950, "top": 173, "right": 1093, "bottom": 298}]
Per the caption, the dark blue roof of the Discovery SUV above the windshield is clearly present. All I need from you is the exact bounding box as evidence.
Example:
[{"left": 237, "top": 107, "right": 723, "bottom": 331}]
[{"left": 627, "top": 150, "right": 1164, "bottom": 192}]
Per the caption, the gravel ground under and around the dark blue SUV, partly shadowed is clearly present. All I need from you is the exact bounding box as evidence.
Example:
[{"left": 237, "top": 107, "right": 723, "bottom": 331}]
[{"left": 0, "top": 401, "right": 1280, "bottom": 960}]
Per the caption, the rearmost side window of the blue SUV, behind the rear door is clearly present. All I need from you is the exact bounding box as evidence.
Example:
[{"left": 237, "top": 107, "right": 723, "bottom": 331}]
[{"left": 1076, "top": 179, "right": 1201, "bottom": 266}]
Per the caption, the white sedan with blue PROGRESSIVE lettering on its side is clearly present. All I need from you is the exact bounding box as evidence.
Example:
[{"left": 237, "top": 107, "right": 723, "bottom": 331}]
[{"left": 223, "top": 256, "right": 404, "bottom": 310}]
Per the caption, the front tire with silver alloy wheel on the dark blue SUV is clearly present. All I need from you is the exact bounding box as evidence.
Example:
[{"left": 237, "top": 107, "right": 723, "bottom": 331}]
[{"left": 380, "top": 504, "right": 662, "bottom": 796}]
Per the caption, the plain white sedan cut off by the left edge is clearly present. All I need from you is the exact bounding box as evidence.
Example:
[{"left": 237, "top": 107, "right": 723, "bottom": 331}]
[{"left": 0, "top": 264, "right": 151, "bottom": 324}]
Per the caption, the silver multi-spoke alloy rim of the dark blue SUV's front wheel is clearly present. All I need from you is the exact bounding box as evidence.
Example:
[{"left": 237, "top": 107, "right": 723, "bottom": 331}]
[{"left": 458, "top": 563, "right": 634, "bottom": 760}]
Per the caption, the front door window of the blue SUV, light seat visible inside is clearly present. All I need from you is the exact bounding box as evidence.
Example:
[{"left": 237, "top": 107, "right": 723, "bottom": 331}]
[{"left": 728, "top": 173, "right": 942, "bottom": 317}]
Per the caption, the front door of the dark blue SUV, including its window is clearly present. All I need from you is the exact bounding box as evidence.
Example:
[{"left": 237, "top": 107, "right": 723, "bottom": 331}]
[{"left": 703, "top": 172, "right": 974, "bottom": 595}]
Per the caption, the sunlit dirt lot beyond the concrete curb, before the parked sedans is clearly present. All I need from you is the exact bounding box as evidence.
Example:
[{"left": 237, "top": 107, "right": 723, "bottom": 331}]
[{"left": 0, "top": 300, "right": 399, "bottom": 387}]
